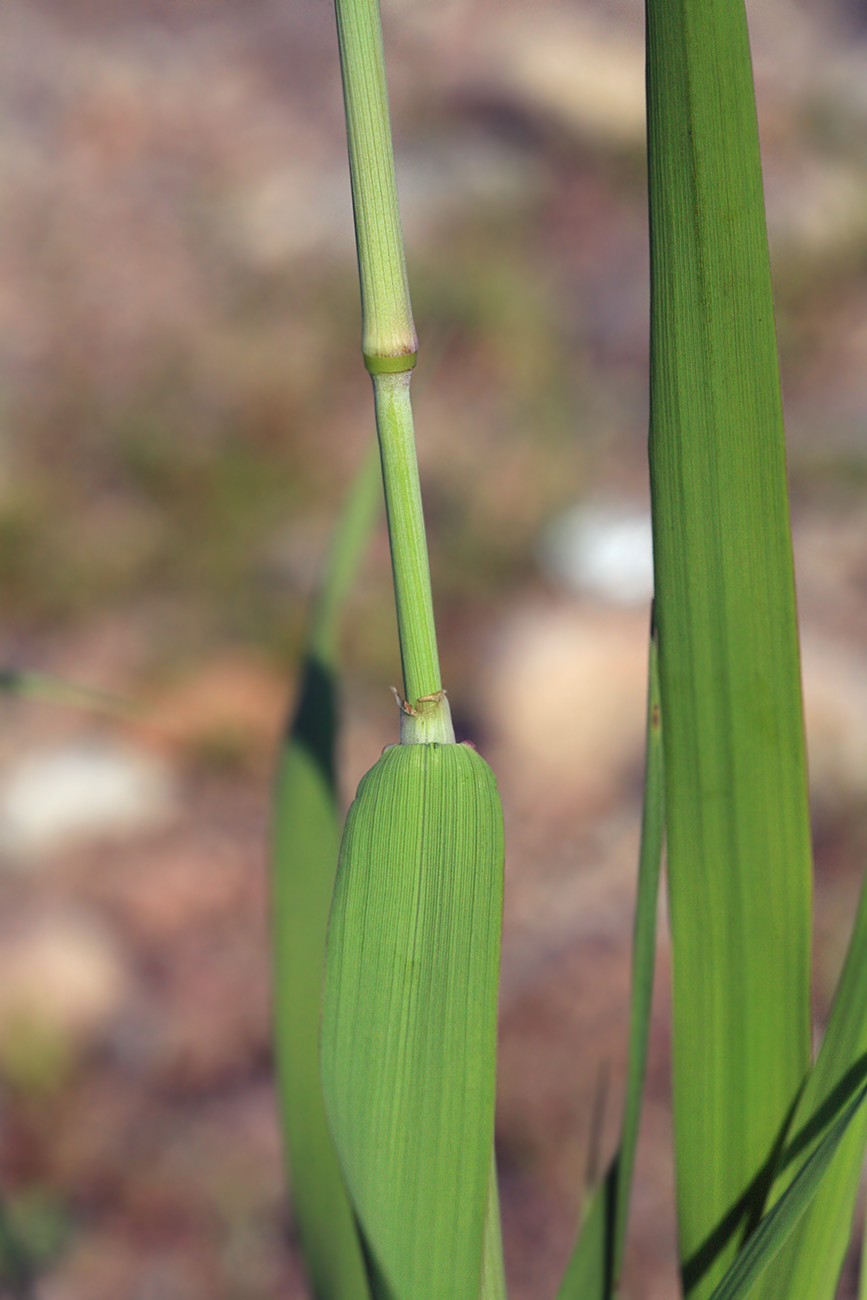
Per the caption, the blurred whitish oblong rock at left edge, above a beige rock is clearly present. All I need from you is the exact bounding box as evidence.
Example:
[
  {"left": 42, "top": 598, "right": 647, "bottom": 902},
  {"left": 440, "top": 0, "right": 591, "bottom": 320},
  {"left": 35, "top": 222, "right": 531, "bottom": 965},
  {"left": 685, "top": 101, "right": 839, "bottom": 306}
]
[{"left": 0, "top": 741, "right": 174, "bottom": 865}]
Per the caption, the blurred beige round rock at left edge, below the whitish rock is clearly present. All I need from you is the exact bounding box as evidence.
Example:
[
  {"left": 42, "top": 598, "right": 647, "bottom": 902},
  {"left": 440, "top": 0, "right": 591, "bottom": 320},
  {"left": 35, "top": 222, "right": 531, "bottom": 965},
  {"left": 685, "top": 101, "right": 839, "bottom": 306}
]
[{"left": 0, "top": 910, "right": 130, "bottom": 1088}]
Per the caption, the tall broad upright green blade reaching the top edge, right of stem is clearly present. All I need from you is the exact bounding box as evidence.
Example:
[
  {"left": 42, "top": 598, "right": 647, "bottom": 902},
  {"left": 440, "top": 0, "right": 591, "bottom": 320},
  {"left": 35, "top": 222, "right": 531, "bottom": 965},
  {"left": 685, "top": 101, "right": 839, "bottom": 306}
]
[{"left": 647, "top": 0, "right": 811, "bottom": 1300}]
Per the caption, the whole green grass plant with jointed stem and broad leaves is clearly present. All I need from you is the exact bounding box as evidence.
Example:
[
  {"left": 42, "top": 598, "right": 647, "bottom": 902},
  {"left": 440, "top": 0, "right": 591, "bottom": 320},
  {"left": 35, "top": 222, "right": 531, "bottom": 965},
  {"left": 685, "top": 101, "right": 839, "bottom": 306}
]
[{"left": 274, "top": 0, "right": 867, "bottom": 1300}]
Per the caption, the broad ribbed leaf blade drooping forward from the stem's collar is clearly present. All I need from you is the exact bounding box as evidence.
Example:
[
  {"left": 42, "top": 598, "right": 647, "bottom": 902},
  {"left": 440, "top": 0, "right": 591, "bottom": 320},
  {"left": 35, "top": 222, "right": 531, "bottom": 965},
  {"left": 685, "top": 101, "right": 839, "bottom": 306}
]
[{"left": 322, "top": 744, "right": 503, "bottom": 1300}]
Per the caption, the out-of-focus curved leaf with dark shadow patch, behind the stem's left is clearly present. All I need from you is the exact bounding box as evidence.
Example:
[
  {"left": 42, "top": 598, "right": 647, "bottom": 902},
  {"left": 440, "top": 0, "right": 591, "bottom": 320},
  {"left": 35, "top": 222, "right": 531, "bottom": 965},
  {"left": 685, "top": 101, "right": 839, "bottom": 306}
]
[{"left": 272, "top": 447, "right": 381, "bottom": 1300}]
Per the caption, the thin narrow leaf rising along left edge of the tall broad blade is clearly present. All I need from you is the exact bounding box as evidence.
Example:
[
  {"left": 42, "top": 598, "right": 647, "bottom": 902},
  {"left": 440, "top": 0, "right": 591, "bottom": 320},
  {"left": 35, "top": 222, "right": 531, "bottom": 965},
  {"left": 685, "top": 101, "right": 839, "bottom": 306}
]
[{"left": 558, "top": 611, "right": 664, "bottom": 1300}]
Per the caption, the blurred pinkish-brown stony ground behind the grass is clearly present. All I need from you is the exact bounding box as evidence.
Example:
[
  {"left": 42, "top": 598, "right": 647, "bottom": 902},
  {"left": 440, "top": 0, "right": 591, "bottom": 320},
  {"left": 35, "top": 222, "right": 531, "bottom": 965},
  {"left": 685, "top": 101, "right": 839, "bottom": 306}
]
[{"left": 0, "top": 0, "right": 867, "bottom": 1300}]
